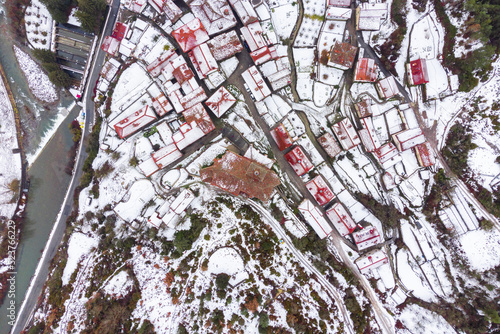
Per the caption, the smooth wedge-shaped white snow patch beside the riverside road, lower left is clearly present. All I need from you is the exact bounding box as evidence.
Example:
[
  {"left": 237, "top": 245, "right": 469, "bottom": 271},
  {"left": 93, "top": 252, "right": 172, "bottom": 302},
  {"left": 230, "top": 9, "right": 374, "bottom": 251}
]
[{"left": 61, "top": 232, "right": 99, "bottom": 285}]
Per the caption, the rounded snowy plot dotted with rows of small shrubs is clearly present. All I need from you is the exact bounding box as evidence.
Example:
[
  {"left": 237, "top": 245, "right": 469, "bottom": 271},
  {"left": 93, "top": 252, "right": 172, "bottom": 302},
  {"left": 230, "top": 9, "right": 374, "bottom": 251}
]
[{"left": 24, "top": 0, "right": 52, "bottom": 50}]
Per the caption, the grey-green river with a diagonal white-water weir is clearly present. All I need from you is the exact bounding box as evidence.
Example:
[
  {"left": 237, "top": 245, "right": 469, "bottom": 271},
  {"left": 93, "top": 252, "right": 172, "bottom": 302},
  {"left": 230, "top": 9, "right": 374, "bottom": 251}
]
[{"left": 0, "top": 8, "right": 80, "bottom": 334}]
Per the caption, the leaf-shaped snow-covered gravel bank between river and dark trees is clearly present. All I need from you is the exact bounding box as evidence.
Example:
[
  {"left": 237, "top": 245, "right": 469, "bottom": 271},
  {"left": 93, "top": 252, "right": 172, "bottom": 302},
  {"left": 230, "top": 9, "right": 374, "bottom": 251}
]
[{"left": 13, "top": 45, "right": 58, "bottom": 103}]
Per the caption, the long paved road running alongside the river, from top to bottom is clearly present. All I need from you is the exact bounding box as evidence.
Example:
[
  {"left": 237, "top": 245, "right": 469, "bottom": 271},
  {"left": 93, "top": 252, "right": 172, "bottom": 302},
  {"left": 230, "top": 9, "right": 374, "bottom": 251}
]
[{"left": 11, "top": 0, "right": 120, "bottom": 334}]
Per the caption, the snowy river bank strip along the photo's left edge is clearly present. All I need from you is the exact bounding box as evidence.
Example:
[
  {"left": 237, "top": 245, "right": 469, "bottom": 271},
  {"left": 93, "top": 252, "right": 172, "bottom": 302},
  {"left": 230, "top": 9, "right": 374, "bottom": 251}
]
[{"left": 0, "top": 80, "right": 21, "bottom": 218}]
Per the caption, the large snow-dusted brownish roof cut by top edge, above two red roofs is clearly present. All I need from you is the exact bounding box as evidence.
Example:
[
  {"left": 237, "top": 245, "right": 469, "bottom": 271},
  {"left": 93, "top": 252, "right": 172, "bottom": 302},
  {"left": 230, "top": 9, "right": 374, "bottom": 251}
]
[{"left": 189, "top": 0, "right": 237, "bottom": 35}]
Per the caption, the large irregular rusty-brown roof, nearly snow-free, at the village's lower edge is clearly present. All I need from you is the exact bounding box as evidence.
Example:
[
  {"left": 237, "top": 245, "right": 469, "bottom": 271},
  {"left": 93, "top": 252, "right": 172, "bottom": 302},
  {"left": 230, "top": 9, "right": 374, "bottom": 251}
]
[{"left": 200, "top": 151, "right": 280, "bottom": 201}]
